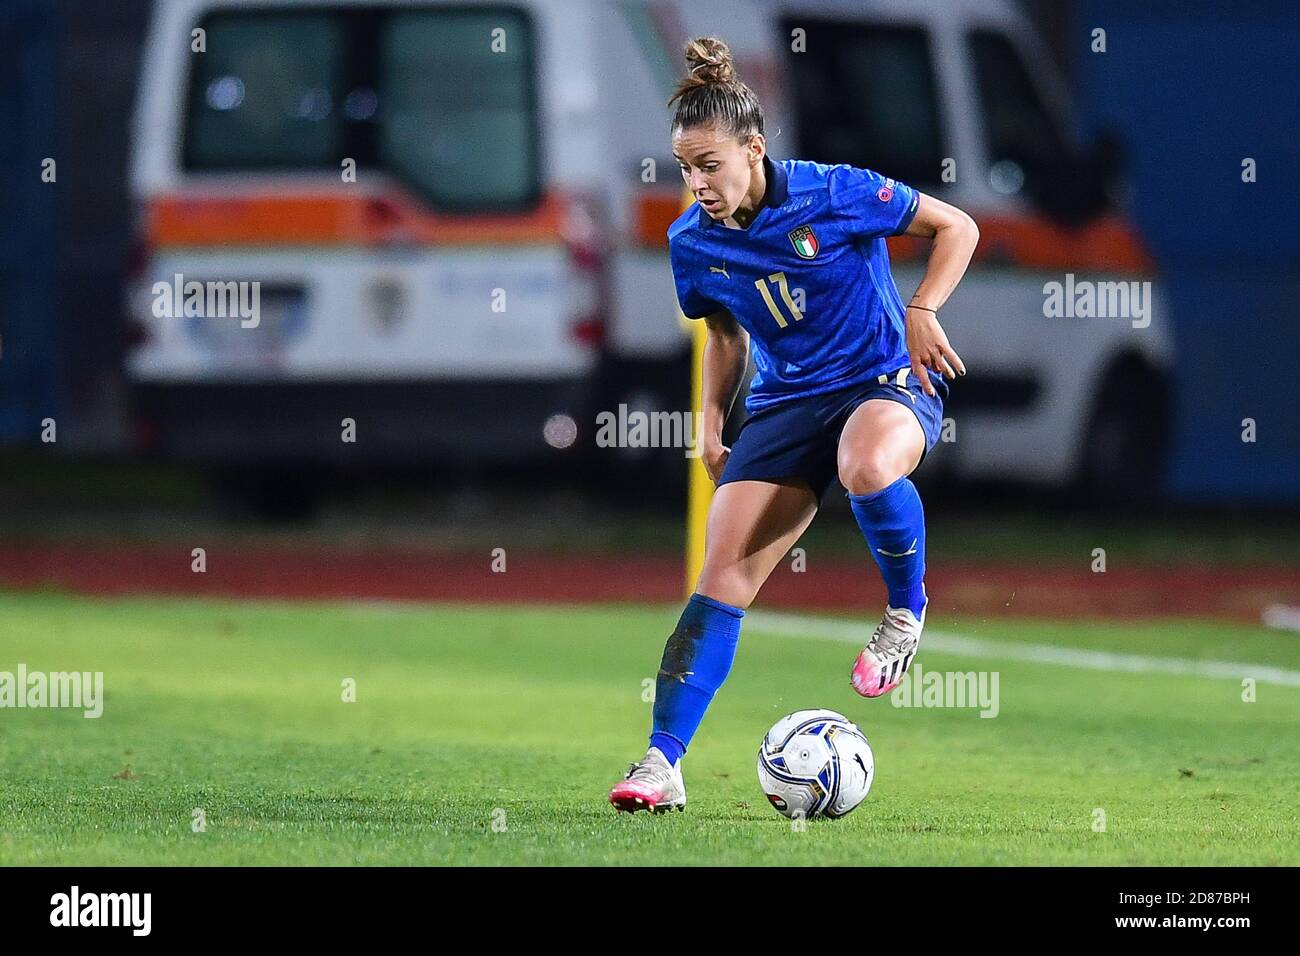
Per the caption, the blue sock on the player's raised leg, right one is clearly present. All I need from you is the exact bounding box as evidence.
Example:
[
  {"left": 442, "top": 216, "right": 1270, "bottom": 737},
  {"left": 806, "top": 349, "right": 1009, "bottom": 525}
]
[{"left": 849, "top": 477, "right": 926, "bottom": 618}]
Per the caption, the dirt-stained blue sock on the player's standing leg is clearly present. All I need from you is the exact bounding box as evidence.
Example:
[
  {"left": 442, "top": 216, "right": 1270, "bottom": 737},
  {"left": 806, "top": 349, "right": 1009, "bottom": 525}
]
[{"left": 650, "top": 594, "right": 745, "bottom": 763}]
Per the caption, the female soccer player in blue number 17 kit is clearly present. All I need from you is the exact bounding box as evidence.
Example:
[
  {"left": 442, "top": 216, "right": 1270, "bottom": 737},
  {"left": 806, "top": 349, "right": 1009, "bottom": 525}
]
[{"left": 610, "top": 36, "right": 979, "bottom": 812}]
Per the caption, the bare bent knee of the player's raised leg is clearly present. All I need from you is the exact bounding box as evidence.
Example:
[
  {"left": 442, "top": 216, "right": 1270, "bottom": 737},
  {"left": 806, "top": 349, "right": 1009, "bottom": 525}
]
[{"left": 836, "top": 398, "right": 926, "bottom": 494}]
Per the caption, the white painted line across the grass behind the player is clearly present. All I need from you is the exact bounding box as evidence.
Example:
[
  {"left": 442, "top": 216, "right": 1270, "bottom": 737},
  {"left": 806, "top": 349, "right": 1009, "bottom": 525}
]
[{"left": 745, "top": 611, "right": 1300, "bottom": 687}]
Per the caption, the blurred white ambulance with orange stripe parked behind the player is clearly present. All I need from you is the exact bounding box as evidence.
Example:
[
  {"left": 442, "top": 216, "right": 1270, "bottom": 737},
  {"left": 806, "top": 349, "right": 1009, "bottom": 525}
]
[{"left": 129, "top": 0, "right": 1169, "bottom": 502}]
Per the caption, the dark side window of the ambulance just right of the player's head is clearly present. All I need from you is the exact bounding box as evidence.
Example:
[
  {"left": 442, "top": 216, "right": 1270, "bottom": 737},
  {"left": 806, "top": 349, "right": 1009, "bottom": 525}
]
[{"left": 781, "top": 17, "right": 945, "bottom": 187}]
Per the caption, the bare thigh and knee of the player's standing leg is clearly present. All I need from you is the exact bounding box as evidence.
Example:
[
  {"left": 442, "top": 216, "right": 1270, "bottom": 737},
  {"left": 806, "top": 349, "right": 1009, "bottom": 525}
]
[{"left": 696, "top": 481, "right": 818, "bottom": 607}]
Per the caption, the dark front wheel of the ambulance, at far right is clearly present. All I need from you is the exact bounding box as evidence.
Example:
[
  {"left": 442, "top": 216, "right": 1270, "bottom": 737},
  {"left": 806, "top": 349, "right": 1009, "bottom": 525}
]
[{"left": 1076, "top": 356, "right": 1171, "bottom": 510}]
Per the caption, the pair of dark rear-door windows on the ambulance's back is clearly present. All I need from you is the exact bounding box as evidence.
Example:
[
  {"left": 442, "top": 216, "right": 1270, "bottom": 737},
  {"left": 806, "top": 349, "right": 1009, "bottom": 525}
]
[{"left": 182, "top": 7, "right": 541, "bottom": 211}]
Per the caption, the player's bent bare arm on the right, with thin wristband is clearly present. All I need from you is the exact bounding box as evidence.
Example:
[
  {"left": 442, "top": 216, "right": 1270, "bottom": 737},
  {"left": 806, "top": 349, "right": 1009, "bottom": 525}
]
[{"left": 905, "top": 193, "right": 979, "bottom": 395}]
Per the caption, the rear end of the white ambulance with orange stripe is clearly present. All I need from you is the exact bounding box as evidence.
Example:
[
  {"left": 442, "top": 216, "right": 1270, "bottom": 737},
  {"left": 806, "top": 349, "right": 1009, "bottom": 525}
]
[{"left": 127, "top": 0, "right": 608, "bottom": 496}]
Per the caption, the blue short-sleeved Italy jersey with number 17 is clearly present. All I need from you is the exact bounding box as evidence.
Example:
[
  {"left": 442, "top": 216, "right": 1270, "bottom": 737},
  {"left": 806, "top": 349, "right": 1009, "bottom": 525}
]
[{"left": 668, "top": 157, "right": 918, "bottom": 412}]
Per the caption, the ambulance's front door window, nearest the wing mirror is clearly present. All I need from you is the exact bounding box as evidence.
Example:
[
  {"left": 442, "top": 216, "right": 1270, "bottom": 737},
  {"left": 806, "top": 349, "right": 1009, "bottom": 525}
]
[{"left": 970, "top": 30, "right": 1070, "bottom": 194}]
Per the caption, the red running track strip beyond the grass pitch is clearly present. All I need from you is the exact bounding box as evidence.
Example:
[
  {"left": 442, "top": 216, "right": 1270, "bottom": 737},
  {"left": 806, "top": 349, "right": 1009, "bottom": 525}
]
[{"left": 0, "top": 545, "right": 1300, "bottom": 622}]
